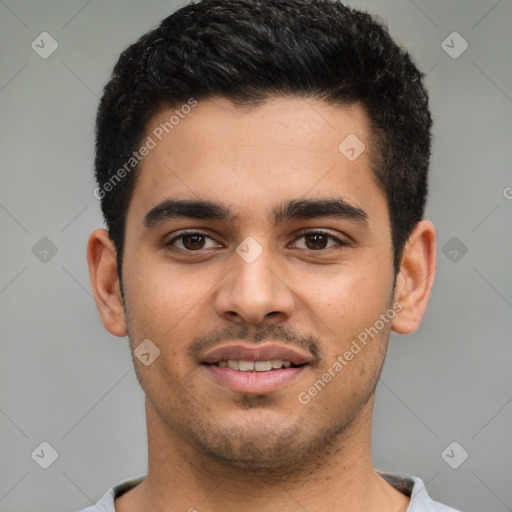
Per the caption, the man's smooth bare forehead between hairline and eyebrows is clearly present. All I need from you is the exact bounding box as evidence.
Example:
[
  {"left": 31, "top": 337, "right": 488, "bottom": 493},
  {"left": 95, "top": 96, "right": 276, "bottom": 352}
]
[{"left": 129, "top": 98, "right": 386, "bottom": 230}]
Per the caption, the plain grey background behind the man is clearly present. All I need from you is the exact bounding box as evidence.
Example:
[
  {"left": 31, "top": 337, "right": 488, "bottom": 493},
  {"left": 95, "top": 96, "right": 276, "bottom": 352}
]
[{"left": 0, "top": 0, "right": 512, "bottom": 512}]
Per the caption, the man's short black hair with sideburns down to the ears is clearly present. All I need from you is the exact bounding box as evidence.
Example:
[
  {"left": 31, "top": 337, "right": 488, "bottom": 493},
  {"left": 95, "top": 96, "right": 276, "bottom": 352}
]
[{"left": 95, "top": 0, "right": 432, "bottom": 286}]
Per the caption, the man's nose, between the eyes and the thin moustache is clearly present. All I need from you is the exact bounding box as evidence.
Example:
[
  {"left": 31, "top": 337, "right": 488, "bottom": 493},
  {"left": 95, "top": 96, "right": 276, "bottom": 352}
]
[{"left": 214, "top": 243, "right": 294, "bottom": 324}]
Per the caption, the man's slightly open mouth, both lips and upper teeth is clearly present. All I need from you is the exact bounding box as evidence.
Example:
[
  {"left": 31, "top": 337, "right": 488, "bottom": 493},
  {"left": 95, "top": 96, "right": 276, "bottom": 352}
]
[{"left": 201, "top": 343, "right": 312, "bottom": 394}]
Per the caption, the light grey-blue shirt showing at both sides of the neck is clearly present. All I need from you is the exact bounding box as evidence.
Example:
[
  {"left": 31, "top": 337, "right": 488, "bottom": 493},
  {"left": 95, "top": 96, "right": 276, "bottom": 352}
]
[{"left": 80, "top": 471, "right": 460, "bottom": 512}]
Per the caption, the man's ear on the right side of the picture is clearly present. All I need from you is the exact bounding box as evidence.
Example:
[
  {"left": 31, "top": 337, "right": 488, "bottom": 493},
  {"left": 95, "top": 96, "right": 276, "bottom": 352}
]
[{"left": 391, "top": 220, "right": 436, "bottom": 334}]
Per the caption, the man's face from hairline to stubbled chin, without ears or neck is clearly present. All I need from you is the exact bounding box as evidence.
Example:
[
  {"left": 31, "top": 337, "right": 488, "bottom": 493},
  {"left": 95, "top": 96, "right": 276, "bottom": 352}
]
[{"left": 119, "top": 98, "right": 394, "bottom": 468}]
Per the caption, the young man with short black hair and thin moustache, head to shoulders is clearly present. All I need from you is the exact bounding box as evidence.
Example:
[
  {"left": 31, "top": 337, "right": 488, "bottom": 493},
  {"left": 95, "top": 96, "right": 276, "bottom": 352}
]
[{"left": 86, "top": 0, "right": 460, "bottom": 512}]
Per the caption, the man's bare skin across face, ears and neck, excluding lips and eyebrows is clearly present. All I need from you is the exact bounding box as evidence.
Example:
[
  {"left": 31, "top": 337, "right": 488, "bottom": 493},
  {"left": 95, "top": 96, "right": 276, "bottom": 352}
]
[{"left": 87, "top": 98, "right": 436, "bottom": 512}]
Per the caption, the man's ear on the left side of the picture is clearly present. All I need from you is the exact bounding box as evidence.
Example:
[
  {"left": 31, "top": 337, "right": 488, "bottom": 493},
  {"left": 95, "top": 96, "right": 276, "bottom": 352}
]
[{"left": 87, "top": 229, "right": 127, "bottom": 336}]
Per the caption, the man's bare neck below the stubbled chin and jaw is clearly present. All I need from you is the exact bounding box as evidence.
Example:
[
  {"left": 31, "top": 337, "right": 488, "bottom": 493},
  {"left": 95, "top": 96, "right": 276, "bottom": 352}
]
[{"left": 116, "top": 396, "right": 409, "bottom": 512}]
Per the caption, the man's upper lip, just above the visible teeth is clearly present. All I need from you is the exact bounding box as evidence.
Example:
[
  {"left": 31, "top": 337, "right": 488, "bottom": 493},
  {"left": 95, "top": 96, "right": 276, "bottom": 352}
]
[{"left": 201, "top": 342, "right": 313, "bottom": 366}]
